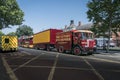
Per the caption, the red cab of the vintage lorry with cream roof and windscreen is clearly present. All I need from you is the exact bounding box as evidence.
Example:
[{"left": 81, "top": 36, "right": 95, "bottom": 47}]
[{"left": 72, "top": 30, "right": 96, "bottom": 54}]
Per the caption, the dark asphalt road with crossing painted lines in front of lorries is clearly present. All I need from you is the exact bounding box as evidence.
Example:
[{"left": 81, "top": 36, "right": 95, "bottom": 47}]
[{"left": 4, "top": 48, "right": 120, "bottom": 80}]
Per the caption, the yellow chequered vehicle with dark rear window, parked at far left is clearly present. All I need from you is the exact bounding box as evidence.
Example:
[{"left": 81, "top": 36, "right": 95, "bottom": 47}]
[{"left": 0, "top": 36, "right": 18, "bottom": 51}]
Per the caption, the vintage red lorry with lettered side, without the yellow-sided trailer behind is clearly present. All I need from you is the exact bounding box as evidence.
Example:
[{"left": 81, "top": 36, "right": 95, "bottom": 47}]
[{"left": 56, "top": 30, "right": 95, "bottom": 55}]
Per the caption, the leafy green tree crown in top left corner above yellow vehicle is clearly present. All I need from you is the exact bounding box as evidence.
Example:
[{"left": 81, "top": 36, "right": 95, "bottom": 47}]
[{"left": 0, "top": 0, "right": 24, "bottom": 29}]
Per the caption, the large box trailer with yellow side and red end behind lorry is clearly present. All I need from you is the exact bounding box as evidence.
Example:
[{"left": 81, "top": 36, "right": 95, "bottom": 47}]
[{"left": 33, "top": 29, "right": 62, "bottom": 51}]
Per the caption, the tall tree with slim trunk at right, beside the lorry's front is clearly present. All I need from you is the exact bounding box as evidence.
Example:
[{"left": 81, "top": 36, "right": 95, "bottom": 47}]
[{"left": 87, "top": 0, "right": 120, "bottom": 51}]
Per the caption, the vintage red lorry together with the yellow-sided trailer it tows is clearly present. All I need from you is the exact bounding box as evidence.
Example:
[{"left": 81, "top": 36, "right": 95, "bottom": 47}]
[{"left": 33, "top": 29, "right": 95, "bottom": 55}]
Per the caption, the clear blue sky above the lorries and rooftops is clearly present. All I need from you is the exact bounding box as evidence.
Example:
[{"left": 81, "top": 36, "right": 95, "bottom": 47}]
[{"left": 2, "top": 0, "right": 89, "bottom": 34}]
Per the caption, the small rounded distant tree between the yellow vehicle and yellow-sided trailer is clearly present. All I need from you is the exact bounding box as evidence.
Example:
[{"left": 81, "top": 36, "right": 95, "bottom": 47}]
[{"left": 16, "top": 25, "right": 33, "bottom": 37}]
